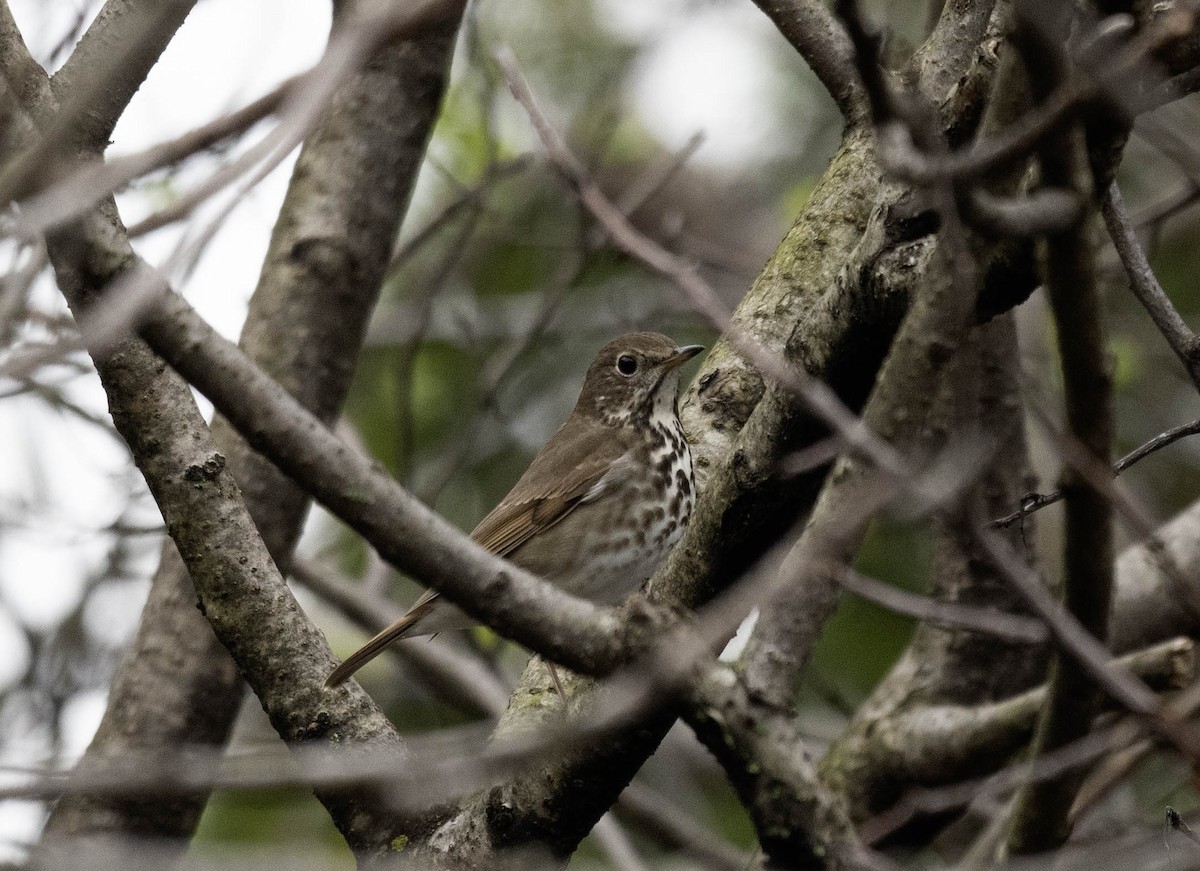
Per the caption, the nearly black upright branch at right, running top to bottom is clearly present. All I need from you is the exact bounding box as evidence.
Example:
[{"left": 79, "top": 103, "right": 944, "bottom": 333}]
[{"left": 1007, "top": 4, "right": 1114, "bottom": 854}]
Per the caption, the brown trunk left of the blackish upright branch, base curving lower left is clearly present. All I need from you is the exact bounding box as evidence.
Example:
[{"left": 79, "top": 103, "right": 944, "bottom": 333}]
[{"left": 821, "top": 314, "right": 1046, "bottom": 819}]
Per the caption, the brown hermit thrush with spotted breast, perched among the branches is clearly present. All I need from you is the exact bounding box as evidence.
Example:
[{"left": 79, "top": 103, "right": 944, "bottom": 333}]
[{"left": 325, "top": 332, "right": 703, "bottom": 686}]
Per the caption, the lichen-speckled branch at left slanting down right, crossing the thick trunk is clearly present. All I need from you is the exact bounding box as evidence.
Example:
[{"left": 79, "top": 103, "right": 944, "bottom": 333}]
[{"left": 2, "top": 0, "right": 468, "bottom": 851}]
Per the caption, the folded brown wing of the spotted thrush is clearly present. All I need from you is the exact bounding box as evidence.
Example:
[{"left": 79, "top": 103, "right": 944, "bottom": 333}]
[{"left": 470, "top": 416, "right": 632, "bottom": 557}]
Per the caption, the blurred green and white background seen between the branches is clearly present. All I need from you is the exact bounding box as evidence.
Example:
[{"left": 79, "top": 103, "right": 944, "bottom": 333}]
[{"left": 0, "top": 0, "right": 1200, "bottom": 869}]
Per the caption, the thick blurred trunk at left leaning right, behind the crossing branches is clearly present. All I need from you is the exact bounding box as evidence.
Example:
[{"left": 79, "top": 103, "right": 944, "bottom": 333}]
[{"left": 39, "top": 10, "right": 454, "bottom": 842}]
